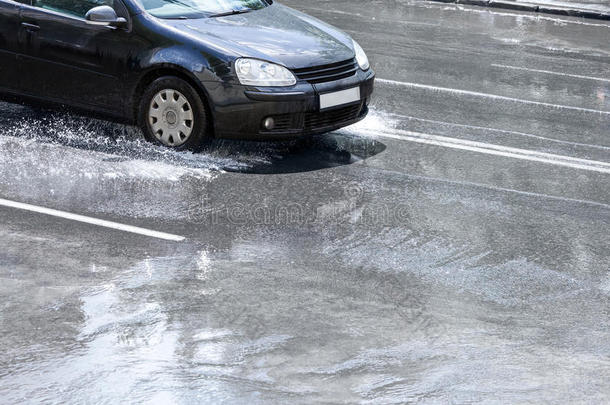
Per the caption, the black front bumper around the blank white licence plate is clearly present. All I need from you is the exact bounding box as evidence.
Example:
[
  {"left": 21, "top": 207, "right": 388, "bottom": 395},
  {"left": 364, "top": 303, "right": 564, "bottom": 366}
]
[{"left": 208, "top": 69, "right": 375, "bottom": 140}]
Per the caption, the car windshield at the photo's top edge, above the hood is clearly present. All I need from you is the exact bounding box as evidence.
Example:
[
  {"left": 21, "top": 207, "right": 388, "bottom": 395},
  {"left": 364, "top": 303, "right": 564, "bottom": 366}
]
[{"left": 137, "top": 0, "right": 269, "bottom": 18}]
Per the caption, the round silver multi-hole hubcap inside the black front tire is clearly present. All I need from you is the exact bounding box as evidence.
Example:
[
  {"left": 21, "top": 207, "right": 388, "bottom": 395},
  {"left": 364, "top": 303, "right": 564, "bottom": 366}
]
[{"left": 148, "top": 89, "right": 195, "bottom": 147}]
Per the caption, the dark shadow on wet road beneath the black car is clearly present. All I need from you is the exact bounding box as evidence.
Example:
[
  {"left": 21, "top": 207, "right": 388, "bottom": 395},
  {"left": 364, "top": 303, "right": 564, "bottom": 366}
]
[{"left": 0, "top": 103, "right": 386, "bottom": 174}]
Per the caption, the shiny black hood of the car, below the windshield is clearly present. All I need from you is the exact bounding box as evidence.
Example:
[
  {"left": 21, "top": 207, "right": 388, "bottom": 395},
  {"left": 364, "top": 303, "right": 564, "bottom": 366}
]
[{"left": 163, "top": 3, "right": 354, "bottom": 69}]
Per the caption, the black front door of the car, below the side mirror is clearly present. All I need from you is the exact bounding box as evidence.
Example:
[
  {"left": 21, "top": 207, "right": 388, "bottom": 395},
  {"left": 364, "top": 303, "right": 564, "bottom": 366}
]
[{"left": 18, "top": 0, "right": 129, "bottom": 114}]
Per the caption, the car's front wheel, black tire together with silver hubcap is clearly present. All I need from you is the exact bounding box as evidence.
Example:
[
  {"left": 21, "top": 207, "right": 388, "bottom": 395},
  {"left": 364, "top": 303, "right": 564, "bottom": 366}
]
[{"left": 138, "top": 76, "right": 212, "bottom": 151}]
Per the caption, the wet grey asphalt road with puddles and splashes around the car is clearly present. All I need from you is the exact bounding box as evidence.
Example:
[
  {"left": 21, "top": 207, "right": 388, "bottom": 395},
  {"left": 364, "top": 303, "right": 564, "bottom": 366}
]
[{"left": 0, "top": 0, "right": 610, "bottom": 404}]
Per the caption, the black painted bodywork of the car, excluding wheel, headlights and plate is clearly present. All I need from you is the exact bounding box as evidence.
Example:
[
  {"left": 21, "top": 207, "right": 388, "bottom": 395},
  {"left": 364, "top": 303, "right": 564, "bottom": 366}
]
[{"left": 0, "top": 0, "right": 374, "bottom": 139}]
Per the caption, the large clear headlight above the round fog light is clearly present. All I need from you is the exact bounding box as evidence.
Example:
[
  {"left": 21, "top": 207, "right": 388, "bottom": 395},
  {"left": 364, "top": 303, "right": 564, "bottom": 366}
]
[{"left": 235, "top": 58, "right": 297, "bottom": 86}]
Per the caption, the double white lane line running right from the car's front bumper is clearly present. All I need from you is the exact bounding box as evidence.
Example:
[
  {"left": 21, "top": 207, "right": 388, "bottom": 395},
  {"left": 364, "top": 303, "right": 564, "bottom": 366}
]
[{"left": 367, "top": 129, "right": 610, "bottom": 174}]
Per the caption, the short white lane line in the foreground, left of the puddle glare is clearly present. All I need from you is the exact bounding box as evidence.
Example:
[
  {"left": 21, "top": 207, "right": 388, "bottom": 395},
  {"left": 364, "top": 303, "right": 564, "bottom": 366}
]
[{"left": 0, "top": 198, "right": 185, "bottom": 242}]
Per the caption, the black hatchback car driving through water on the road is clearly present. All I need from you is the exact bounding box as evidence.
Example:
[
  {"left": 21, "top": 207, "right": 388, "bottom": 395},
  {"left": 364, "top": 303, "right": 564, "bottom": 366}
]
[{"left": 0, "top": 0, "right": 375, "bottom": 149}]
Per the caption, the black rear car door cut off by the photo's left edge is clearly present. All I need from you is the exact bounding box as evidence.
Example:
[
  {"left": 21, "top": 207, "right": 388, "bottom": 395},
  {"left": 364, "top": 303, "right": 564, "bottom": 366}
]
[{"left": 0, "top": 0, "right": 21, "bottom": 90}]
